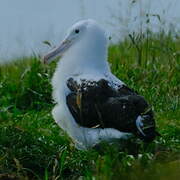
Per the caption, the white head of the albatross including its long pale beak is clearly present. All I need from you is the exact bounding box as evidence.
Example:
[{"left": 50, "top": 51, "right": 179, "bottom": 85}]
[{"left": 43, "top": 19, "right": 107, "bottom": 68}]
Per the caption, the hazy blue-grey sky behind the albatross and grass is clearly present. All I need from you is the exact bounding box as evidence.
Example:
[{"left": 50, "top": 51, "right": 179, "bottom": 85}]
[{"left": 0, "top": 0, "right": 180, "bottom": 62}]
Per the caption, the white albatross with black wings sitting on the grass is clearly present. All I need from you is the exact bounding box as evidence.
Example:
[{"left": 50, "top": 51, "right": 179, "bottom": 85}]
[{"left": 42, "top": 19, "right": 157, "bottom": 149}]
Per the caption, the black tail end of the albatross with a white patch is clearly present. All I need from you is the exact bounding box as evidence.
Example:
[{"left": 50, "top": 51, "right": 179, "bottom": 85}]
[{"left": 136, "top": 114, "right": 159, "bottom": 142}]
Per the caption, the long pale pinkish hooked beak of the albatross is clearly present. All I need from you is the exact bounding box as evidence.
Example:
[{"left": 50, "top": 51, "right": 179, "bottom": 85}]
[{"left": 42, "top": 39, "right": 72, "bottom": 64}]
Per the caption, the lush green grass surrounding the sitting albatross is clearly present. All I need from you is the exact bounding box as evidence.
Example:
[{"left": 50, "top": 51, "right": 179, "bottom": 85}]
[{"left": 0, "top": 35, "right": 180, "bottom": 180}]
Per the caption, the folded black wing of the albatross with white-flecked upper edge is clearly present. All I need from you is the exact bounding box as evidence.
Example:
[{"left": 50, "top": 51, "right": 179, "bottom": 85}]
[{"left": 66, "top": 78, "right": 155, "bottom": 141}]
